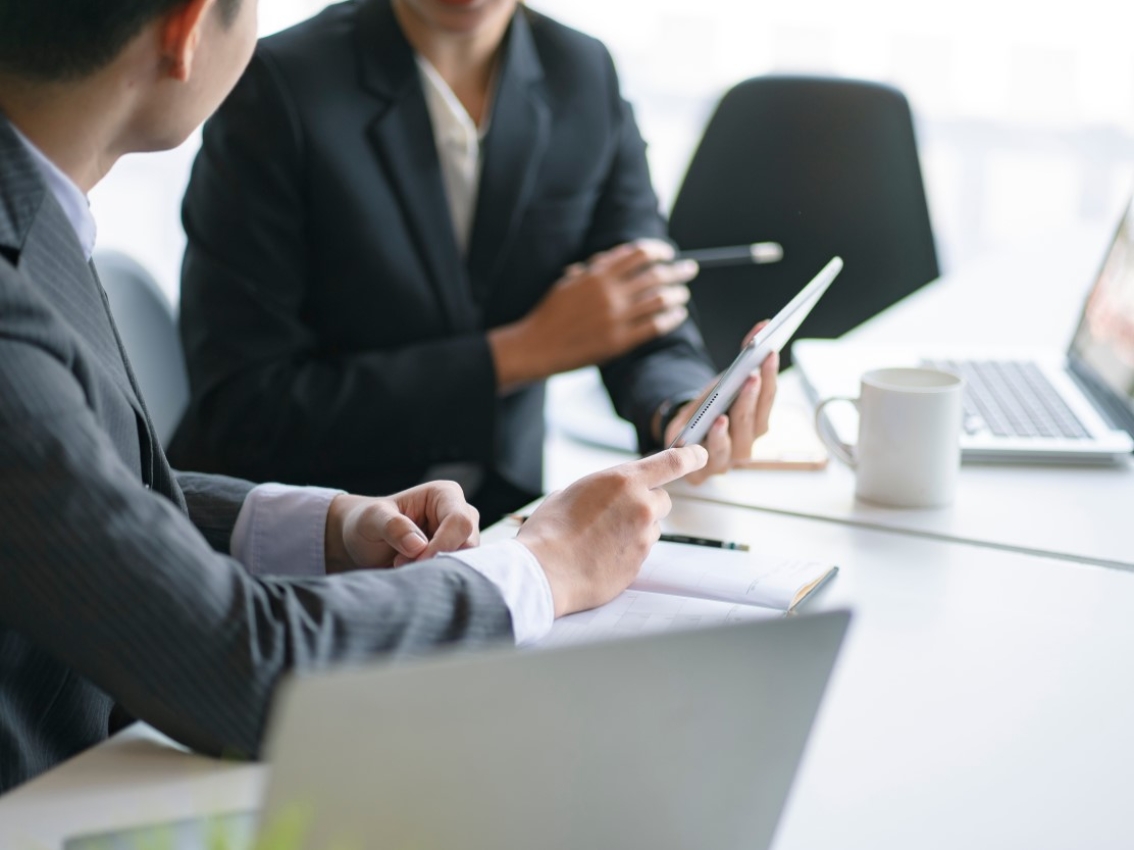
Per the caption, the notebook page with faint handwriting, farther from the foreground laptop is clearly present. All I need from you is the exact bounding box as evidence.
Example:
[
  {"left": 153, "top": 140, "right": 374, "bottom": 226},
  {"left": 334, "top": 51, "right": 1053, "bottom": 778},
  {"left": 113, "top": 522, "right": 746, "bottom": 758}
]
[{"left": 631, "top": 543, "right": 833, "bottom": 611}]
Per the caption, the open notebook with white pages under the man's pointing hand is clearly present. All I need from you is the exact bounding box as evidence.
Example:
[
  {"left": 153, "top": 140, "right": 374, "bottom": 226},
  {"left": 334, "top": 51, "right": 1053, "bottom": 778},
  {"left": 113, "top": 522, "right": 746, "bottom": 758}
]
[{"left": 540, "top": 542, "right": 838, "bottom": 646}]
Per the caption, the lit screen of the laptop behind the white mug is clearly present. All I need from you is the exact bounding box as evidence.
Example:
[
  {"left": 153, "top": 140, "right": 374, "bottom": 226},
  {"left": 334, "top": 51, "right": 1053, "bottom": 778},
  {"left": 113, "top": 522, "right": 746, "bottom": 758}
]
[{"left": 1070, "top": 201, "right": 1134, "bottom": 423}]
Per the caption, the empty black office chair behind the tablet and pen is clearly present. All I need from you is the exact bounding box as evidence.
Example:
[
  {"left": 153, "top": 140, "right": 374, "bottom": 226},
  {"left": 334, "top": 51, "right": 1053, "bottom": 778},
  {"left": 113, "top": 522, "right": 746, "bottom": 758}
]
[{"left": 670, "top": 77, "right": 939, "bottom": 368}]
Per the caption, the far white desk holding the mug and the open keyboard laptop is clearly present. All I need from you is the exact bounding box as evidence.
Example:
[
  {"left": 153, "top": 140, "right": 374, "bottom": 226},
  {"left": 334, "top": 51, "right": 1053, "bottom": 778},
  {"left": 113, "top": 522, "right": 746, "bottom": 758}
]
[{"left": 547, "top": 230, "right": 1134, "bottom": 568}]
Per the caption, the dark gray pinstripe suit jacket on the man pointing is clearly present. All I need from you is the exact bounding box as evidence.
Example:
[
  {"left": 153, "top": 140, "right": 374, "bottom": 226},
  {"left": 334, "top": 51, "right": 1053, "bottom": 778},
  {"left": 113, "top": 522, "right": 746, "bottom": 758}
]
[{"left": 0, "top": 116, "right": 511, "bottom": 791}]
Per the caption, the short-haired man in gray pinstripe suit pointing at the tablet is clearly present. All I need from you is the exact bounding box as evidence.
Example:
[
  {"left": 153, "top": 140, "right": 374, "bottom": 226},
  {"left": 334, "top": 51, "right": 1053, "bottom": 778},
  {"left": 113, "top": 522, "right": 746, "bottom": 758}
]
[{"left": 0, "top": 0, "right": 706, "bottom": 791}]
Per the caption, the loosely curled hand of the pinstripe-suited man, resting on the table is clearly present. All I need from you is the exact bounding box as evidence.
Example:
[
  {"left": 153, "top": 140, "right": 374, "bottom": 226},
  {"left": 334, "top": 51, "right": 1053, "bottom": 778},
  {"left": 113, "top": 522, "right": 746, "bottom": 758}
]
[{"left": 325, "top": 481, "right": 481, "bottom": 573}]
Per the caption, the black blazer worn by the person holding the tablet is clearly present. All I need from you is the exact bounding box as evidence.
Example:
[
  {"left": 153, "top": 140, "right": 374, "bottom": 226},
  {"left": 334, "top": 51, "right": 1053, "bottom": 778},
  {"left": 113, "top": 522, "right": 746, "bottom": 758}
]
[{"left": 171, "top": 0, "right": 712, "bottom": 492}]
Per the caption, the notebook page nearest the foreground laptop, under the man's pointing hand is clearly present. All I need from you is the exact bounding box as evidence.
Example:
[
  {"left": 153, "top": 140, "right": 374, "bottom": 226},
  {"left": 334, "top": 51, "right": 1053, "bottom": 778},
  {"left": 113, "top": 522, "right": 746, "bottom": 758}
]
[{"left": 539, "top": 590, "right": 785, "bottom": 646}]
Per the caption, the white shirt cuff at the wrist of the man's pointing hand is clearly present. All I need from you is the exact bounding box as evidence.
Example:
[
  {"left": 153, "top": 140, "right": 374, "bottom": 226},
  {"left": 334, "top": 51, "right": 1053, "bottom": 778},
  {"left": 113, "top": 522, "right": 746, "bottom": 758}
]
[{"left": 442, "top": 541, "right": 556, "bottom": 646}]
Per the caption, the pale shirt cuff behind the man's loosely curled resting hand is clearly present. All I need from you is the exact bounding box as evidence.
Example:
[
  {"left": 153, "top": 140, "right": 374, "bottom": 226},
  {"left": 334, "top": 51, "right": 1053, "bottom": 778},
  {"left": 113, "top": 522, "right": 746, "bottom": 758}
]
[{"left": 229, "top": 484, "right": 342, "bottom": 577}]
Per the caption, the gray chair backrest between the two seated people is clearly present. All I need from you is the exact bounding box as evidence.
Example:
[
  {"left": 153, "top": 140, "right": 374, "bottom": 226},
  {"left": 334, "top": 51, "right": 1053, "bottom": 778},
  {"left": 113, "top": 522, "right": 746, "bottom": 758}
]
[{"left": 94, "top": 252, "right": 189, "bottom": 445}]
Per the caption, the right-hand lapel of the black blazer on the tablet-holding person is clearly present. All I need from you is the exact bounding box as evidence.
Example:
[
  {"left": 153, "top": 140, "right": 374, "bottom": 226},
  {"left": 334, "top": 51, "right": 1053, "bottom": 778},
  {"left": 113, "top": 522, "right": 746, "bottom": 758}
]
[{"left": 468, "top": 9, "right": 551, "bottom": 299}]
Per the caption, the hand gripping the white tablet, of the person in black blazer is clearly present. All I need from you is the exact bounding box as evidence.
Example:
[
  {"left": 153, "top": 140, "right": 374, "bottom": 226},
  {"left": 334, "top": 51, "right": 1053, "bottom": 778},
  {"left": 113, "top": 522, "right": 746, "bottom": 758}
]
[{"left": 662, "top": 322, "right": 779, "bottom": 484}]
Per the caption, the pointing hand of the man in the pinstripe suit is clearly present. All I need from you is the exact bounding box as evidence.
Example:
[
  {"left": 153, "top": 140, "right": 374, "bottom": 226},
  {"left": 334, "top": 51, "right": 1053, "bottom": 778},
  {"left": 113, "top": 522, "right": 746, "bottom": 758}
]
[{"left": 517, "top": 445, "right": 709, "bottom": 617}]
